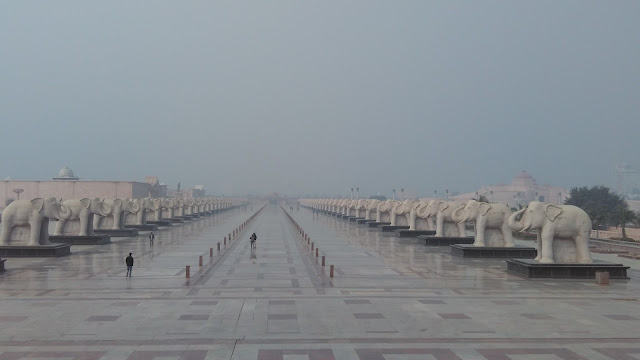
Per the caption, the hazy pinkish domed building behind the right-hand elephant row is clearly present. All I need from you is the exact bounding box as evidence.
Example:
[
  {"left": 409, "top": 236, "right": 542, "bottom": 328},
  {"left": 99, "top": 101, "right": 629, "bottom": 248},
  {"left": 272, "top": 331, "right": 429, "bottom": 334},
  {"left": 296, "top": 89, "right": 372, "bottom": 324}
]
[{"left": 450, "top": 170, "right": 569, "bottom": 207}]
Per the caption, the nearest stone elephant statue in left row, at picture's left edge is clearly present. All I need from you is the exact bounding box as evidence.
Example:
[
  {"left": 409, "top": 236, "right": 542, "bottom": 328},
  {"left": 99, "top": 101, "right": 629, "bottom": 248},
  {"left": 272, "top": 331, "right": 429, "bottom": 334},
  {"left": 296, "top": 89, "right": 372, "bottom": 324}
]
[{"left": 0, "top": 197, "right": 71, "bottom": 246}]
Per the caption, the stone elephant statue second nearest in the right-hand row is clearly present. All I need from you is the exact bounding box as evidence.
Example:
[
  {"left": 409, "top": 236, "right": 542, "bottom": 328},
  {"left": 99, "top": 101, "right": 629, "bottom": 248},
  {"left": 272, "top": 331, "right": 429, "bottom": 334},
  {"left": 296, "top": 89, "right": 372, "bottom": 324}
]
[{"left": 453, "top": 200, "right": 515, "bottom": 247}]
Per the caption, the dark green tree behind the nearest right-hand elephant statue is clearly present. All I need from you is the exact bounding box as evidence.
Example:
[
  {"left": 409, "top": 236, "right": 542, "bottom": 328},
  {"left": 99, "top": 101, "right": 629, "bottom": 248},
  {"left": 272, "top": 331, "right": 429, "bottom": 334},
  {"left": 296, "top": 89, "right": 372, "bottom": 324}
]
[{"left": 564, "top": 185, "right": 629, "bottom": 229}]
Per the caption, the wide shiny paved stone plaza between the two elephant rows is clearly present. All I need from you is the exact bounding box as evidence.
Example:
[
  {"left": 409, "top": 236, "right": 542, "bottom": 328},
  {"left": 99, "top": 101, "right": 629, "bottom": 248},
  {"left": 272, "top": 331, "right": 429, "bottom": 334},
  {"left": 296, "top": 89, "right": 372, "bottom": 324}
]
[{"left": 0, "top": 205, "right": 640, "bottom": 360}]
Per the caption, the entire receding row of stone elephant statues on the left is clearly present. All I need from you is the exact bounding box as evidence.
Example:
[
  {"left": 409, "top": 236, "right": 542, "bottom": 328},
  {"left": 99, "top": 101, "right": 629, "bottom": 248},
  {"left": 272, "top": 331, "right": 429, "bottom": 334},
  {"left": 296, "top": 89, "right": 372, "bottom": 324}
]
[{"left": 0, "top": 197, "right": 243, "bottom": 246}]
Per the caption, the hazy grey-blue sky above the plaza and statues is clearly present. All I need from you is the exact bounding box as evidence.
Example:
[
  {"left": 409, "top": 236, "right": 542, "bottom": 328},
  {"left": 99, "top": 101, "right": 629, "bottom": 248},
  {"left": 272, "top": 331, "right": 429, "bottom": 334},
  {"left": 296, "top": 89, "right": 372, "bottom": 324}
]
[{"left": 0, "top": 0, "right": 640, "bottom": 195}]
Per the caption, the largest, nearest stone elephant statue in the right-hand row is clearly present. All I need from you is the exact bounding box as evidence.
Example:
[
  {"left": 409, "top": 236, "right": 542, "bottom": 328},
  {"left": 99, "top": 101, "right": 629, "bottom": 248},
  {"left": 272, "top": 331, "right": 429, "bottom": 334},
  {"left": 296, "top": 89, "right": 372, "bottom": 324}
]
[{"left": 508, "top": 201, "right": 592, "bottom": 264}]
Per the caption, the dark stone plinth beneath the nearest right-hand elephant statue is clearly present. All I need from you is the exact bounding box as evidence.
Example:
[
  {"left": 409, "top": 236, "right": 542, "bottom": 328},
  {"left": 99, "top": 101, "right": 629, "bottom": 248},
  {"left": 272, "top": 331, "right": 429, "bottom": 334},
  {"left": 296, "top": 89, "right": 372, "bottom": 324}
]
[{"left": 507, "top": 259, "right": 629, "bottom": 280}]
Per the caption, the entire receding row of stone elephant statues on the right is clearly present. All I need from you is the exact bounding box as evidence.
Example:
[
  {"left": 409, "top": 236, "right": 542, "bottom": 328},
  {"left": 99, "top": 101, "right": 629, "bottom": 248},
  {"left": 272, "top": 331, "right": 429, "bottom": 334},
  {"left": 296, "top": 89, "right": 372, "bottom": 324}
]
[{"left": 300, "top": 199, "right": 592, "bottom": 264}]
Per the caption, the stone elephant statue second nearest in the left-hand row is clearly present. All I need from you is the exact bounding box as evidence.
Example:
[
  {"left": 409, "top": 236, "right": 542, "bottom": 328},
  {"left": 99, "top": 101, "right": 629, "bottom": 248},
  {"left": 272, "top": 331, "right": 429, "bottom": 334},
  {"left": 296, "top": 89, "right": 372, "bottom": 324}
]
[{"left": 53, "top": 198, "right": 113, "bottom": 236}]
